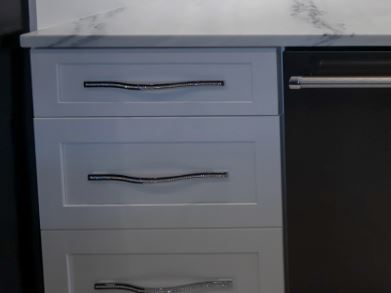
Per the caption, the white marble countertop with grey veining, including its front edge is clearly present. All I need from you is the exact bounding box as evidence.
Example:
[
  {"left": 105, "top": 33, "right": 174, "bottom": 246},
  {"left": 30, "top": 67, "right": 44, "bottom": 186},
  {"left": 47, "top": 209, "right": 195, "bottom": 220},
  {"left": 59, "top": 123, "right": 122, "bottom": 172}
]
[{"left": 21, "top": 0, "right": 391, "bottom": 47}]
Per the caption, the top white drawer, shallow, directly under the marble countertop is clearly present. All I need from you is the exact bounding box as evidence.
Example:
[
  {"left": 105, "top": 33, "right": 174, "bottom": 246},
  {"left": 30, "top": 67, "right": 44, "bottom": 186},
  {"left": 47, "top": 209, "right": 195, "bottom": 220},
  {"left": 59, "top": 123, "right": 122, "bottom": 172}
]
[{"left": 32, "top": 49, "right": 278, "bottom": 117}]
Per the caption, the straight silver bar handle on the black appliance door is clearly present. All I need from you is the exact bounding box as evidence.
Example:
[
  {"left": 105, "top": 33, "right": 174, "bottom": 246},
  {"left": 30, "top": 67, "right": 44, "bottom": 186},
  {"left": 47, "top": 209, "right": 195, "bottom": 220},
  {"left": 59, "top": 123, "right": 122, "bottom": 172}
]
[{"left": 289, "top": 76, "right": 391, "bottom": 90}]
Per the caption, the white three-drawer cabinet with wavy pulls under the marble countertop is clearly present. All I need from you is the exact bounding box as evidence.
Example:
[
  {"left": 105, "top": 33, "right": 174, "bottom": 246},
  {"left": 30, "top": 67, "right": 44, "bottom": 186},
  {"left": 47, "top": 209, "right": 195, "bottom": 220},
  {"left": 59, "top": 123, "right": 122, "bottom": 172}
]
[{"left": 32, "top": 48, "right": 284, "bottom": 293}]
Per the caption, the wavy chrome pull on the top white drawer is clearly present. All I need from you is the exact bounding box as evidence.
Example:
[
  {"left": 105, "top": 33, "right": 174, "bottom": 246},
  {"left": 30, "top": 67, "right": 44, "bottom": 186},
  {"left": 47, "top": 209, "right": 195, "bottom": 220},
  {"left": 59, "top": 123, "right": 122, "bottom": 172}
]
[{"left": 84, "top": 80, "right": 225, "bottom": 91}]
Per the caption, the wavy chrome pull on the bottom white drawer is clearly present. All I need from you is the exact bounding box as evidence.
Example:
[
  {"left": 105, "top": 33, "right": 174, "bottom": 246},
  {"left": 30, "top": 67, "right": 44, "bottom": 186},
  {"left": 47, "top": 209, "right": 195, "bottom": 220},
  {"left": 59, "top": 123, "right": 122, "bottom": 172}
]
[{"left": 94, "top": 280, "right": 233, "bottom": 293}]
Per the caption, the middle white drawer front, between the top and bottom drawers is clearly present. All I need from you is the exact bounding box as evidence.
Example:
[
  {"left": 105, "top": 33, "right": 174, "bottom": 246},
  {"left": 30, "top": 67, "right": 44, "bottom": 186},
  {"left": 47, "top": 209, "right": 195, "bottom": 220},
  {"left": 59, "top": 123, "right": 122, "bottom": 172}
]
[{"left": 35, "top": 116, "right": 282, "bottom": 229}]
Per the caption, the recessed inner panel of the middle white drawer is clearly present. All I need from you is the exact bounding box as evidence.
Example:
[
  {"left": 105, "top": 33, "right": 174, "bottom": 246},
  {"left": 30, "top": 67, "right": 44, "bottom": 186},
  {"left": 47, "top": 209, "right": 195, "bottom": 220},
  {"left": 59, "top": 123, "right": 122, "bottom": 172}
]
[{"left": 61, "top": 138, "right": 257, "bottom": 206}]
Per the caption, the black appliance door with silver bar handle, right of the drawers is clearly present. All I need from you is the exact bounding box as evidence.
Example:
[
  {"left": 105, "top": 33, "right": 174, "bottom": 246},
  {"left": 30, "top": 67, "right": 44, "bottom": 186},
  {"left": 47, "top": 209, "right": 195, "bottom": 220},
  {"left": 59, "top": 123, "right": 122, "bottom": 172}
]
[{"left": 284, "top": 51, "right": 391, "bottom": 293}]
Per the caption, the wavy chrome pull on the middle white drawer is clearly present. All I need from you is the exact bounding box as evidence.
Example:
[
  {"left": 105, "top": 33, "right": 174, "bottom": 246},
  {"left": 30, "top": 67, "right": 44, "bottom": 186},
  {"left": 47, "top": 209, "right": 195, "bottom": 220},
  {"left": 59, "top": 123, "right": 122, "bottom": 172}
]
[{"left": 88, "top": 171, "right": 228, "bottom": 184}]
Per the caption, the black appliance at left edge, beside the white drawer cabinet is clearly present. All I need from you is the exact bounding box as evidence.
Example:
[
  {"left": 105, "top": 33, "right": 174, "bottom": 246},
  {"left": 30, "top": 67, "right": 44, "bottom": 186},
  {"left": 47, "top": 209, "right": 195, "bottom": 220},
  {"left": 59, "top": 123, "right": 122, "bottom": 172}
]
[{"left": 0, "top": 0, "right": 43, "bottom": 293}]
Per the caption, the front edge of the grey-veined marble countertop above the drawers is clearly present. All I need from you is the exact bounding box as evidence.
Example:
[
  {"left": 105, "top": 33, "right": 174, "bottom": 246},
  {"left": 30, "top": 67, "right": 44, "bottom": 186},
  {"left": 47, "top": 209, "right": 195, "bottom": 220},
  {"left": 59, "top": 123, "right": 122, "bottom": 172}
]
[{"left": 20, "top": 33, "right": 391, "bottom": 48}]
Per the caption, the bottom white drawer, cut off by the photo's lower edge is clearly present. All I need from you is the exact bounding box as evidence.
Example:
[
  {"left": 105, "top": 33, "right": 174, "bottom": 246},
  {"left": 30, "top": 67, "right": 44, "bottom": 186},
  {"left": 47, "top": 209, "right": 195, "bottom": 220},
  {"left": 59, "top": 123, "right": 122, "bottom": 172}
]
[{"left": 42, "top": 229, "right": 284, "bottom": 293}]
